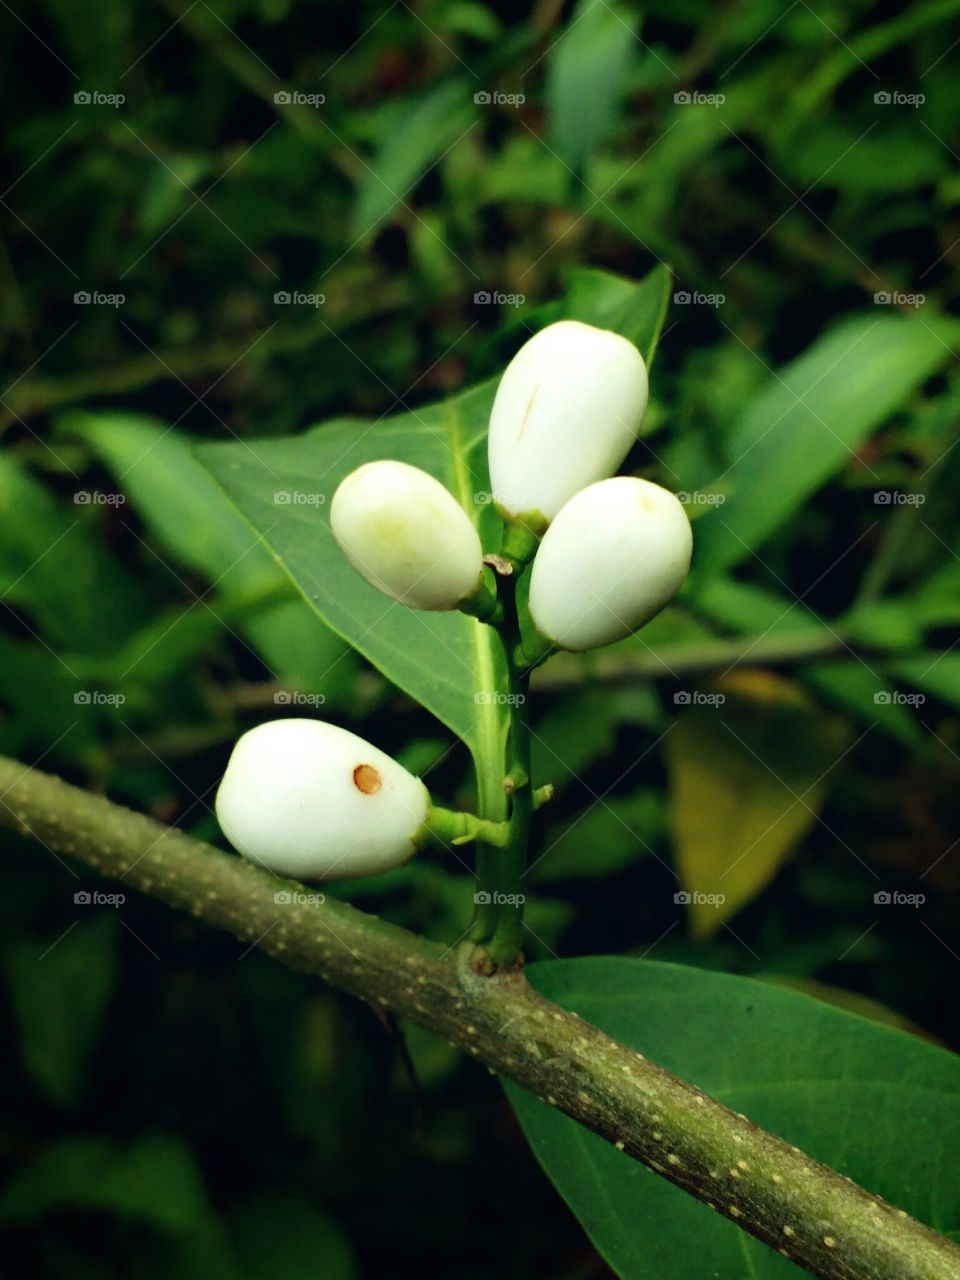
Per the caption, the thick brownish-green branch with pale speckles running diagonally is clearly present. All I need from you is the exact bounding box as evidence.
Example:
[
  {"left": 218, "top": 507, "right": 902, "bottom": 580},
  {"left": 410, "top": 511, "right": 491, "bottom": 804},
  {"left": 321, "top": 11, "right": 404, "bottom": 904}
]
[{"left": 0, "top": 756, "right": 960, "bottom": 1280}]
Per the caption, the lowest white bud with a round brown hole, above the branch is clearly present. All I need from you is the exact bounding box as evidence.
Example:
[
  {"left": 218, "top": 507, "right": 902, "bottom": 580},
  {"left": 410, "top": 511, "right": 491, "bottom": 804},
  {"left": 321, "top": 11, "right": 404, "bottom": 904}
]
[{"left": 216, "top": 719, "right": 430, "bottom": 879}]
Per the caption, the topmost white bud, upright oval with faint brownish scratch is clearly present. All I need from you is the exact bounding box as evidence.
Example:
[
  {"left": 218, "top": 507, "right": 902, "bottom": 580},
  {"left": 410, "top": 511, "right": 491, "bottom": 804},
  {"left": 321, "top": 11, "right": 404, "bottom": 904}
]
[{"left": 489, "top": 320, "right": 646, "bottom": 521}]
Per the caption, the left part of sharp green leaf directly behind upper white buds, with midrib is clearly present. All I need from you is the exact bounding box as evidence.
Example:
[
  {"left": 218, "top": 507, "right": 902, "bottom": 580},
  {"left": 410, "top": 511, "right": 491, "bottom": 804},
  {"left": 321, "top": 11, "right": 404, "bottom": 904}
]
[{"left": 200, "top": 384, "right": 506, "bottom": 760}]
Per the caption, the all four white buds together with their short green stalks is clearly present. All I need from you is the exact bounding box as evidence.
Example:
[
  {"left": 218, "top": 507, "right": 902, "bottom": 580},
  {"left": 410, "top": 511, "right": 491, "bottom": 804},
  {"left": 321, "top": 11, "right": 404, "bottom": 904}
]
[{"left": 216, "top": 320, "right": 692, "bottom": 879}]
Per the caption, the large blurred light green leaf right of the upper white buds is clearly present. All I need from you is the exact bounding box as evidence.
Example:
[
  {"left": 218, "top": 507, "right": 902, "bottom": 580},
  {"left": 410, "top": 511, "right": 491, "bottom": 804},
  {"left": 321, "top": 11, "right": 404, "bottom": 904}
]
[{"left": 694, "top": 312, "right": 952, "bottom": 576}]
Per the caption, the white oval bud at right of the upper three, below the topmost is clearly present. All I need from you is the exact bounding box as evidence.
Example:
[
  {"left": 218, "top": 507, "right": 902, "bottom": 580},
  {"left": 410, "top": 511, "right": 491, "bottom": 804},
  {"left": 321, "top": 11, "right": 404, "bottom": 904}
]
[{"left": 530, "top": 476, "right": 694, "bottom": 650}]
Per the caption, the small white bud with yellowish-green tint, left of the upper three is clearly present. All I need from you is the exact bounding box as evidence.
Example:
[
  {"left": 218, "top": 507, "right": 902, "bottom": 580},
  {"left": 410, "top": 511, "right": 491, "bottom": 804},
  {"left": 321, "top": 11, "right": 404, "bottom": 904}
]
[{"left": 330, "top": 461, "right": 484, "bottom": 609}]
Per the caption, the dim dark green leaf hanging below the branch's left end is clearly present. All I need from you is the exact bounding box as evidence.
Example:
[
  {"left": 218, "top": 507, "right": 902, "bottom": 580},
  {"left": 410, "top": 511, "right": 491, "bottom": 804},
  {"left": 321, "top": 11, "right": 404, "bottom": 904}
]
[{"left": 10, "top": 911, "right": 118, "bottom": 1106}]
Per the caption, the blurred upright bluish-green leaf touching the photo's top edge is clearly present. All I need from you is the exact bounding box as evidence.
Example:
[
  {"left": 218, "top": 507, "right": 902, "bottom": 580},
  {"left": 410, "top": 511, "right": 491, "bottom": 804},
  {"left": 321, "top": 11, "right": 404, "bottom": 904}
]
[{"left": 547, "top": 0, "right": 637, "bottom": 173}]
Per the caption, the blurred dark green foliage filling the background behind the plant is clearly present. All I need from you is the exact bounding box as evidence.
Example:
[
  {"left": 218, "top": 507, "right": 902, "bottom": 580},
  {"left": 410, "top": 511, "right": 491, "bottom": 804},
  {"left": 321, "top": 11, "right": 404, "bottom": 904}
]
[{"left": 0, "top": 0, "right": 960, "bottom": 1280}]
